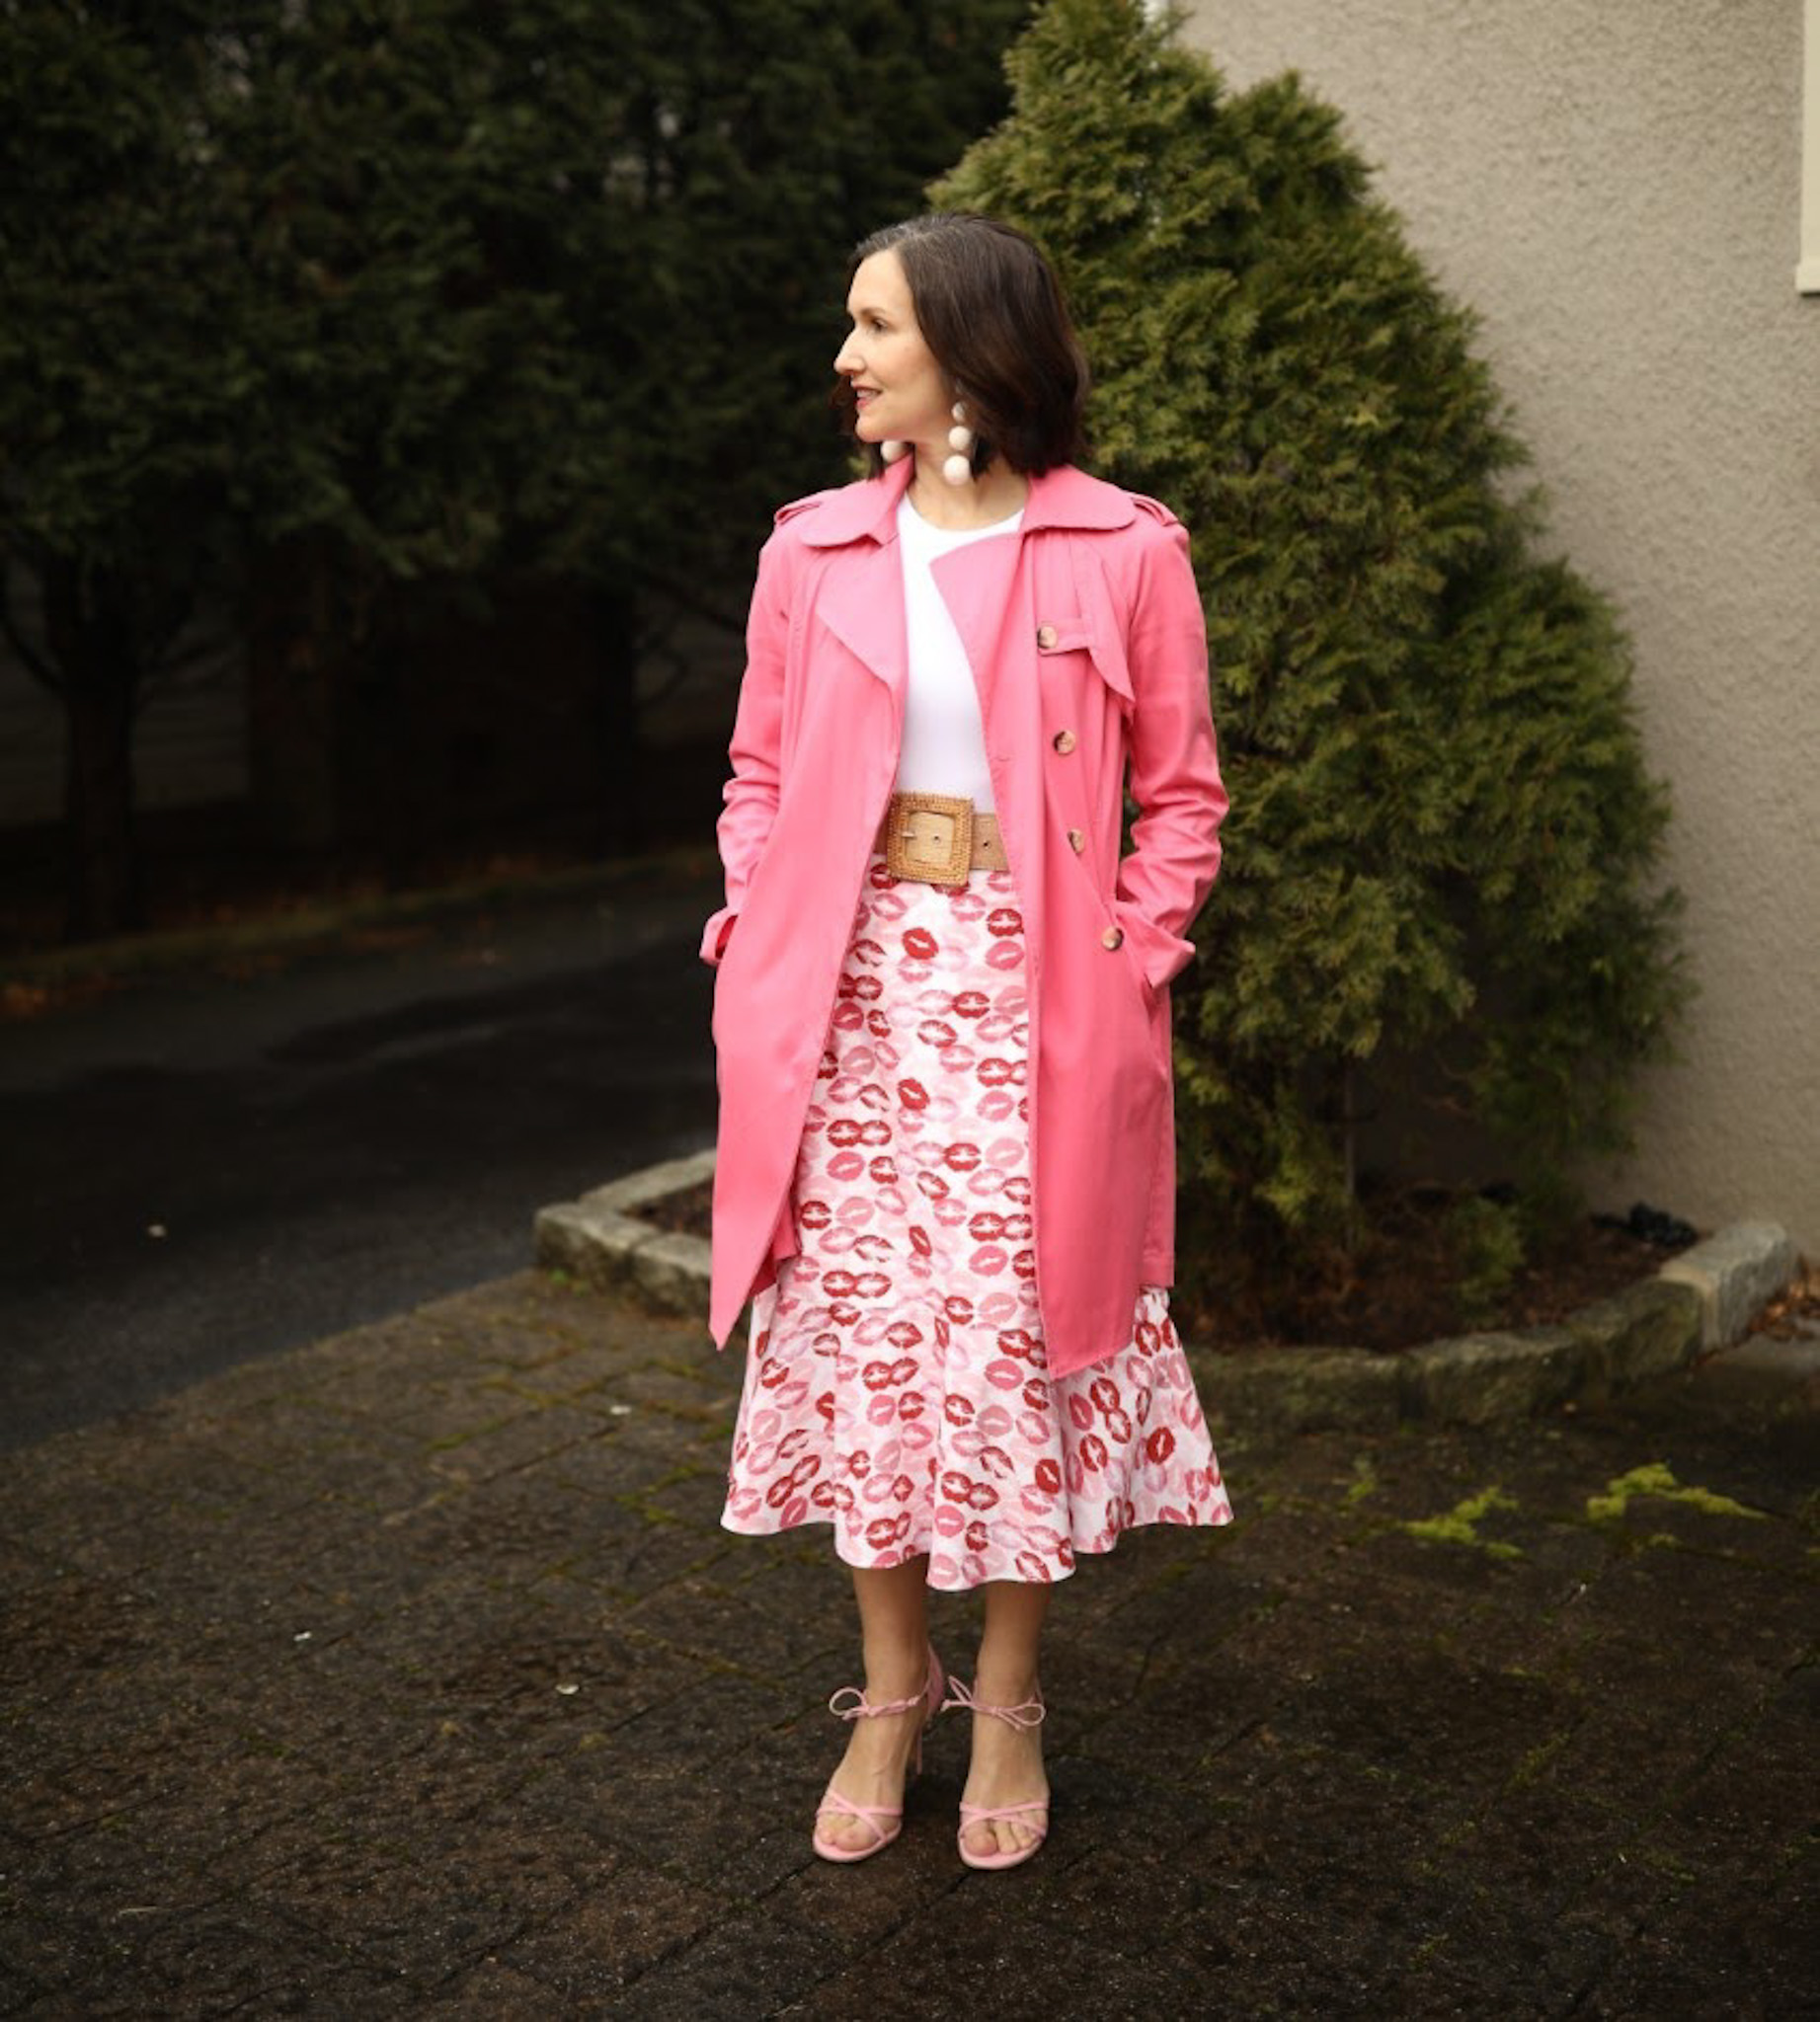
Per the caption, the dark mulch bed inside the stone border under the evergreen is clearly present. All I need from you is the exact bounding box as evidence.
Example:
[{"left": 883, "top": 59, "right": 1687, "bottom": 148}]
[{"left": 637, "top": 1181, "right": 1691, "bottom": 1353}]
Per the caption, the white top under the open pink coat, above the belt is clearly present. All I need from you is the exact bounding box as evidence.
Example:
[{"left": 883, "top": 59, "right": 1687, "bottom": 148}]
[{"left": 898, "top": 494, "right": 1023, "bottom": 815}]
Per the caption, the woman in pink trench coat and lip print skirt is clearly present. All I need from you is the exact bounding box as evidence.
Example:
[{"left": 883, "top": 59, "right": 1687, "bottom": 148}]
[{"left": 702, "top": 214, "right": 1231, "bottom": 1868}]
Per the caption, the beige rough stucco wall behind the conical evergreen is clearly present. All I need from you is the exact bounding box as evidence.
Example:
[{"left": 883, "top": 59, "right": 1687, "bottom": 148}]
[{"left": 1187, "top": 0, "right": 1820, "bottom": 1258}]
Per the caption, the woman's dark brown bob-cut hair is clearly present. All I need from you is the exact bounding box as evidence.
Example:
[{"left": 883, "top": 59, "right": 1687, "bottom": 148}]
[{"left": 833, "top": 210, "right": 1088, "bottom": 477}]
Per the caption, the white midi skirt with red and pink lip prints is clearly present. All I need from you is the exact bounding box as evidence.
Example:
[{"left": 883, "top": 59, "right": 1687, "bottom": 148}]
[{"left": 722, "top": 857, "right": 1231, "bottom": 1590}]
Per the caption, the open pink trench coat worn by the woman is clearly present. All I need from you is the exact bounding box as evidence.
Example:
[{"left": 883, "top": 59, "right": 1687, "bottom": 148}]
[{"left": 702, "top": 459, "right": 1227, "bottom": 1375}]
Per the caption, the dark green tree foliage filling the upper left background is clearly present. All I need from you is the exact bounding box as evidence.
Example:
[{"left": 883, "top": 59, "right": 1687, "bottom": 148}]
[{"left": 0, "top": 0, "right": 1029, "bottom": 930}]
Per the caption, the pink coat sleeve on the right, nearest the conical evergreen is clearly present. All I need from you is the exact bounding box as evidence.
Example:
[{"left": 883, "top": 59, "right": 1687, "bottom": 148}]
[{"left": 1114, "top": 513, "right": 1227, "bottom": 991}]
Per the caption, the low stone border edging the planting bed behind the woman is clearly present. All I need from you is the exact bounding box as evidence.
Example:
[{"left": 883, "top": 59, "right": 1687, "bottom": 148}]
[{"left": 534, "top": 1148, "right": 1800, "bottom": 1430}]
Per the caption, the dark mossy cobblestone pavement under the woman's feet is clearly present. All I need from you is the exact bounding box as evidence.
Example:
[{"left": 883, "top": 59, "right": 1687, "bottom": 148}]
[{"left": 0, "top": 1272, "right": 1820, "bottom": 2022}]
